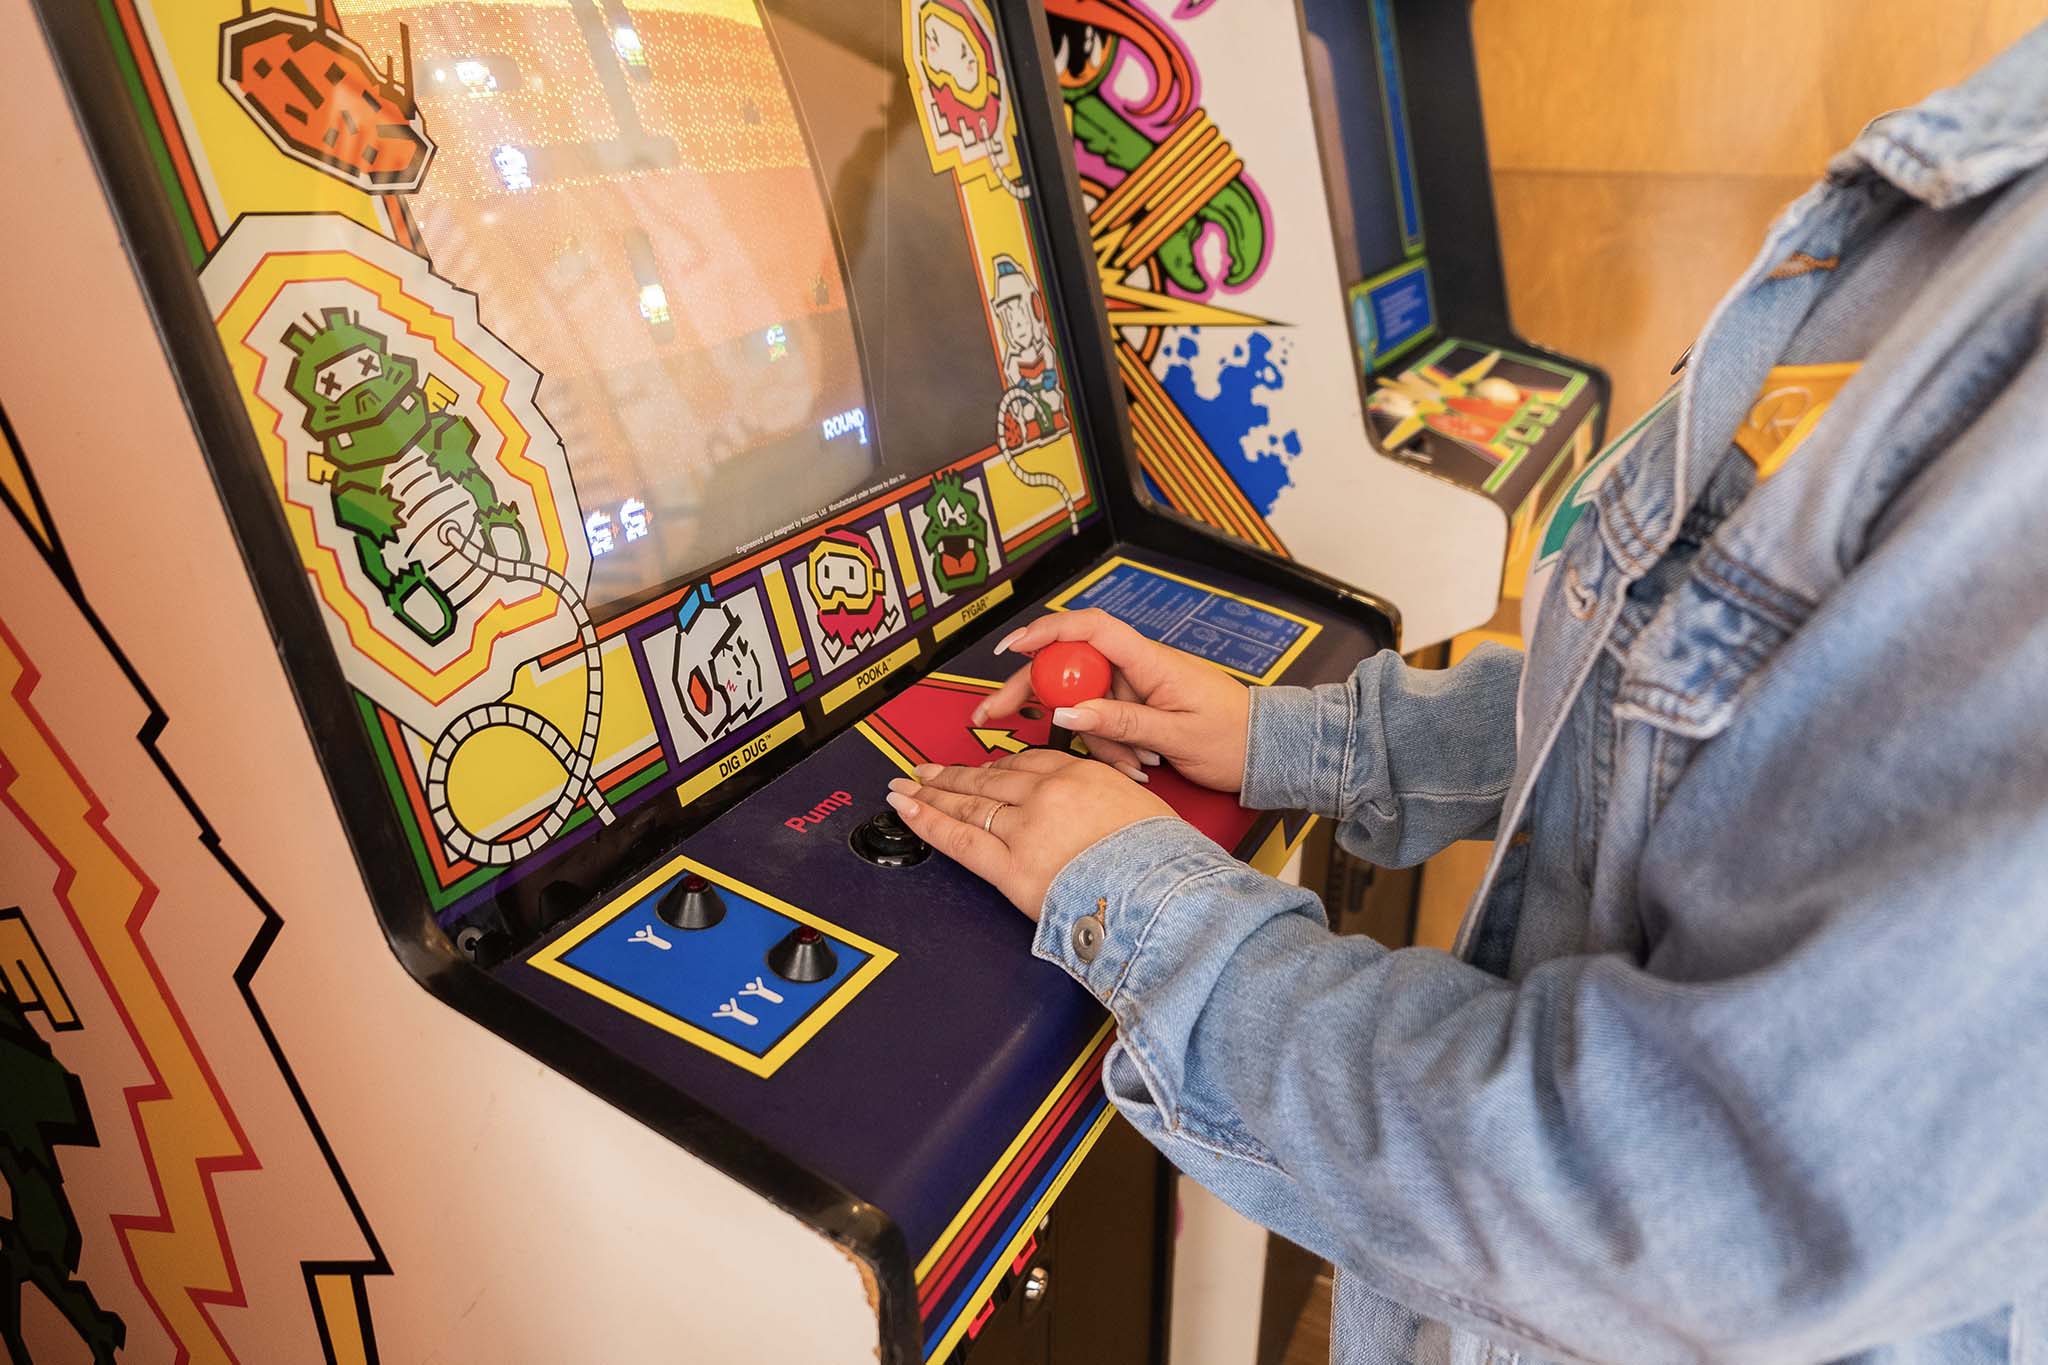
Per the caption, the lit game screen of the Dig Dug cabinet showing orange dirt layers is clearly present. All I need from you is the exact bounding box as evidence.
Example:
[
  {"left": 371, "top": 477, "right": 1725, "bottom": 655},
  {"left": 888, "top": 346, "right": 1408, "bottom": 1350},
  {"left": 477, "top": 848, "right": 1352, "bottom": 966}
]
[{"left": 340, "top": 0, "right": 999, "bottom": 614}]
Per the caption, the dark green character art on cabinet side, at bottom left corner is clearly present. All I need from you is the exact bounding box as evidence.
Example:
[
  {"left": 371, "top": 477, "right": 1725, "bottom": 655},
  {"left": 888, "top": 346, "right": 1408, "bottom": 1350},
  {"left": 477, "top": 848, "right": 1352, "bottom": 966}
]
[{"left": 0, "top": 988, "right": 127, "bottom": 1365}]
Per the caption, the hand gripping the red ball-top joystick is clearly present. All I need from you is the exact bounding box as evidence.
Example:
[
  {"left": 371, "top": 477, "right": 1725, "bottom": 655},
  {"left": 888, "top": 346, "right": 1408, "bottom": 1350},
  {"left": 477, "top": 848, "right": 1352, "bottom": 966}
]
[{"left": 975, "top": 608, "right": 1251, "bottom": 792}]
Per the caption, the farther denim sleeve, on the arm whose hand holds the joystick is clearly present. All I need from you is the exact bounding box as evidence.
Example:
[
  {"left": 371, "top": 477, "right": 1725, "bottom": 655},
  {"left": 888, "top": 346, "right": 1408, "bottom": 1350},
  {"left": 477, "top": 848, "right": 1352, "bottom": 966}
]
[{"left": 1243, "top": 645, "right": 1522, "bottom": 868}]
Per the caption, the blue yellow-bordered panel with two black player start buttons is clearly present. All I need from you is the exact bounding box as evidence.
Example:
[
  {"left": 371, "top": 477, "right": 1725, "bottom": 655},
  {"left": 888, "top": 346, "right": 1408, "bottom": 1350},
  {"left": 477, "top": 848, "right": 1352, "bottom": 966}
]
[{"left": 537, "top": 868, "right": 872, "bottom": 1058}]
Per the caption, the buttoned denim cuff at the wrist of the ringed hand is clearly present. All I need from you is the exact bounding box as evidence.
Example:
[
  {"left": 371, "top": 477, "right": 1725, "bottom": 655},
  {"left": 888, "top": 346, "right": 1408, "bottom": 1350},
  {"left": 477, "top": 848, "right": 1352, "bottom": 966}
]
[{"left": 1032, "top": 814, "right": 1241, "bottom": 1009}]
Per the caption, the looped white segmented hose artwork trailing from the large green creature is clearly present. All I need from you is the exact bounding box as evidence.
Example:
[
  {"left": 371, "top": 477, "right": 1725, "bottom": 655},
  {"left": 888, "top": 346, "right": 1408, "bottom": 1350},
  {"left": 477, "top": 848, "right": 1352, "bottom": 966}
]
[{"left": 426, "top": 522, "right": 602, "bottom": 868}]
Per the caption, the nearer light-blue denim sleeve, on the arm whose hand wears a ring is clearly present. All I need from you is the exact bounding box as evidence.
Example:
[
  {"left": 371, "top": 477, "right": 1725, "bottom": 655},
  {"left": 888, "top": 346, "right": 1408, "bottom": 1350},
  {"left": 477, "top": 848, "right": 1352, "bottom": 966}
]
[{"left": 1036, "top": 327, "right": 2048, "bottom": 1361}]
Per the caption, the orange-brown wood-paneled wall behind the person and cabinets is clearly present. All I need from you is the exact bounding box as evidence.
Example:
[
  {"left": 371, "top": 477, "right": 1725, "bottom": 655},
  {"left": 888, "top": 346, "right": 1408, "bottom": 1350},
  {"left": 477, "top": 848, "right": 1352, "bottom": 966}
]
[{"left": 1417, "top": 0, "right": 2048, "bottom": 948}]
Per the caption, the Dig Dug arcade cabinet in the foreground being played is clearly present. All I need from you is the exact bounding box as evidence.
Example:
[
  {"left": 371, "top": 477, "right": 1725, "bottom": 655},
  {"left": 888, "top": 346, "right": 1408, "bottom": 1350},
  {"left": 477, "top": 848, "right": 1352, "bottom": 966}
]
[{"left": 0, "top": 0, "right": 1393, "bottom": 1365}]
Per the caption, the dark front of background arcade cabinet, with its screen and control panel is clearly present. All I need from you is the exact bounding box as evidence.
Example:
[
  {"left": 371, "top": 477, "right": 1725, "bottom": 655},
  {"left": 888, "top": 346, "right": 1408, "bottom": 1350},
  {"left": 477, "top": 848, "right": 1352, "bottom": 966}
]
[{"left": 1300, "top": 0, "right": 1610, "bottom": 596}]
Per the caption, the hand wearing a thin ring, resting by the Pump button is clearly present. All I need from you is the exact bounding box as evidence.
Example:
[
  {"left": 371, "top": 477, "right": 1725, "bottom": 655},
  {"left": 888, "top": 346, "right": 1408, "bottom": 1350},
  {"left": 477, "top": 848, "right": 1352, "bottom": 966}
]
[{"left": 889, "top": 749, "right": 1174, "bottom": 919}]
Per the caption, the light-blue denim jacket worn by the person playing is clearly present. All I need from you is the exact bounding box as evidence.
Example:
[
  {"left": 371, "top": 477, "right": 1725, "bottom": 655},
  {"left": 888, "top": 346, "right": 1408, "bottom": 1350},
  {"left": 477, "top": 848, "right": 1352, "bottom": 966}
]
[{"left": 1034, "top": 27, "right": 2048, "bottom": 1365}]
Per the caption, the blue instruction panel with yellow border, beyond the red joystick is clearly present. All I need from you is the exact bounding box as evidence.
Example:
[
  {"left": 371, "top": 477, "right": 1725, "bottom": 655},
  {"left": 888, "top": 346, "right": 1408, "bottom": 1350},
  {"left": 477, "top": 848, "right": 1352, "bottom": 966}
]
[{"left": 1059, "top": 561, "right": 1315, "bottom": 681}]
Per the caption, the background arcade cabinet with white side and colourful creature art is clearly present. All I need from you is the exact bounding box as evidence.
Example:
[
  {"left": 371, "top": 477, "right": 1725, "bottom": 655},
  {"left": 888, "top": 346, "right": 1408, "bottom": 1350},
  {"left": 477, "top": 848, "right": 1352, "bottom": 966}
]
[{"left": 1044, "top": 0, "right": 1606, "bottom": 651}]
